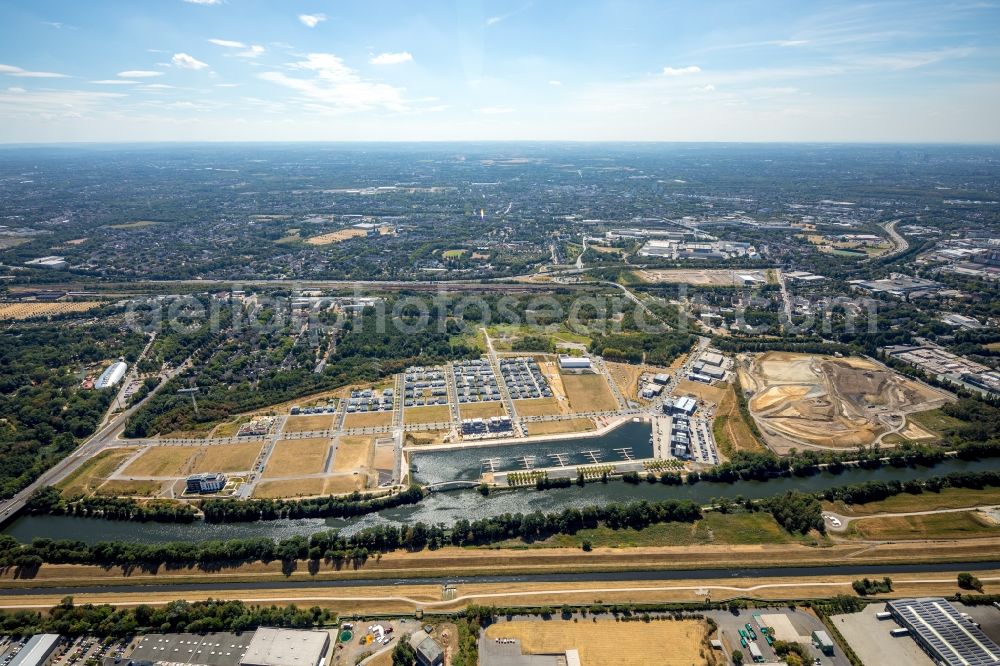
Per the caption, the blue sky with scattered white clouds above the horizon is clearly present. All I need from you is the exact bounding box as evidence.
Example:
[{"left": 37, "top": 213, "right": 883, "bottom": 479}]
[{"left": 0, "top": 0, "right": 1000, "bottom": 143}]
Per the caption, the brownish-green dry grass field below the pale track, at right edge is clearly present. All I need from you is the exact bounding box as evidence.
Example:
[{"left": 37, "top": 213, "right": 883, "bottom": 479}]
[{"left": 847, "top": 511, "right": 1000, "bottom": 541}]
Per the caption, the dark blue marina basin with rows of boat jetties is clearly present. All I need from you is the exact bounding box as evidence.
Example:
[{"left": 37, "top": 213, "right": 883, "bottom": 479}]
[{"left": 410, "top": 421, "right": 653, "bottom": 485}]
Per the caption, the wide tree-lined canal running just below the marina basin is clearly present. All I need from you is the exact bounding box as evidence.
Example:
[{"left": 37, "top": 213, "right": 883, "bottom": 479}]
[{"left": 4, "top": 454, "right": 1000, "bottom": 543}]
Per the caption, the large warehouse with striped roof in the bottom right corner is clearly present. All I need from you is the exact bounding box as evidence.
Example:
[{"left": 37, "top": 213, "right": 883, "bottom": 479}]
[{"left": 885, "top": 597, "right": 1000, "bottom": 666}]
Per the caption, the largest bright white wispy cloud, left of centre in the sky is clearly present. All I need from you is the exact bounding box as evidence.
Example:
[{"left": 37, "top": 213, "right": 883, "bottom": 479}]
[{"left": 259, "top": 53, "right": 408, "bottom": 112}]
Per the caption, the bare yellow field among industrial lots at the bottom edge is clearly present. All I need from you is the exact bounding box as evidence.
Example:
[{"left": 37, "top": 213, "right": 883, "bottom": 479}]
[{"left": 486, "top": 619, "right": 714, "bottom": 666}]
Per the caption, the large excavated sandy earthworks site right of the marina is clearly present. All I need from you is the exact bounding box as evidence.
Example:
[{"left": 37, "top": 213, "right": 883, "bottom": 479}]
[{"left": 737, "top": 352, "right": 953, "bottom": 453}]
